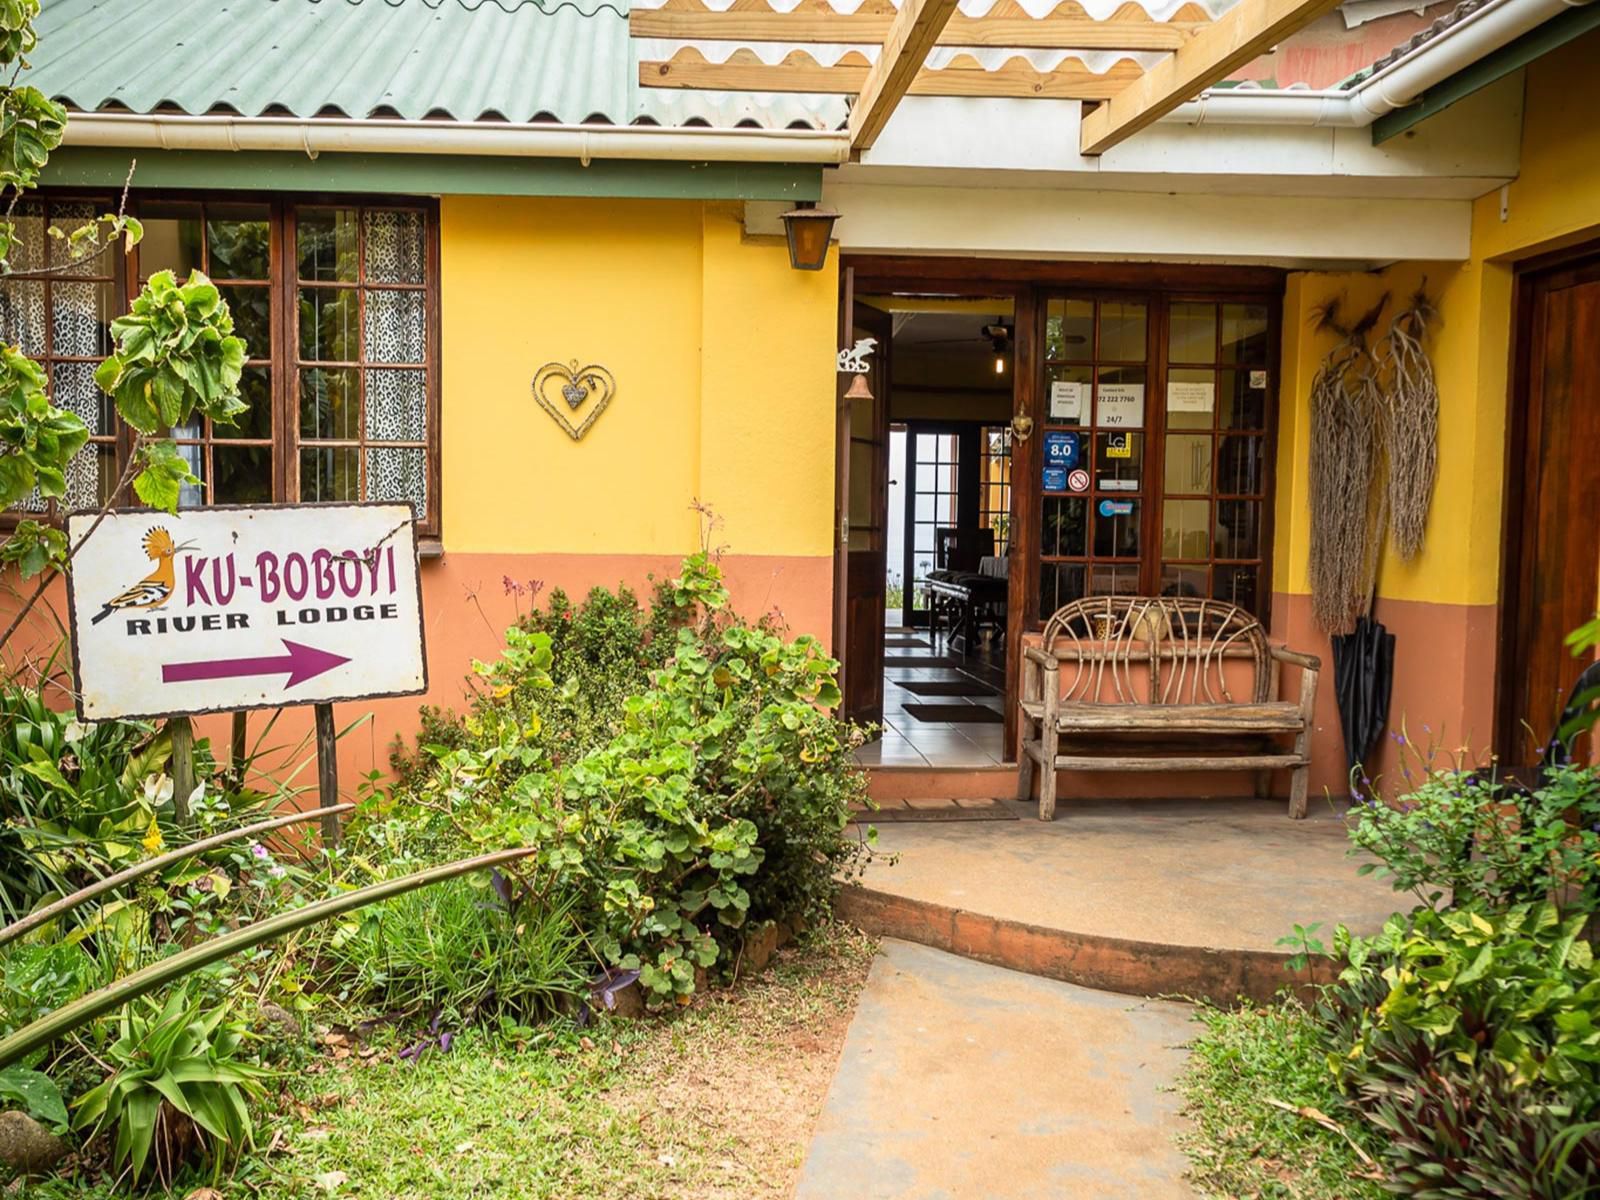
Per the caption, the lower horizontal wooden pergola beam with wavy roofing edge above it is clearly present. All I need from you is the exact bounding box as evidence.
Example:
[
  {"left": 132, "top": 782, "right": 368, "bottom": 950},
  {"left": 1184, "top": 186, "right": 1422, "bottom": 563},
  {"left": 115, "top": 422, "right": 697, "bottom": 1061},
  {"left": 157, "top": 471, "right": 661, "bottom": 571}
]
[{"left": 638, "top": 46, "right": 1142, "bottom": 101}]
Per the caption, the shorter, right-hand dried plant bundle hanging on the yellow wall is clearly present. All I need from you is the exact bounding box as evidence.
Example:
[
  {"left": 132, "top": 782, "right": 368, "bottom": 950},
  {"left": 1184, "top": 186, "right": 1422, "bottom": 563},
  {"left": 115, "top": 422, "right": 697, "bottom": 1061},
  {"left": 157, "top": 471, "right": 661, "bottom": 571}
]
[{"left": 1373, "top": 289, "right": 1438, "bottom": 560}]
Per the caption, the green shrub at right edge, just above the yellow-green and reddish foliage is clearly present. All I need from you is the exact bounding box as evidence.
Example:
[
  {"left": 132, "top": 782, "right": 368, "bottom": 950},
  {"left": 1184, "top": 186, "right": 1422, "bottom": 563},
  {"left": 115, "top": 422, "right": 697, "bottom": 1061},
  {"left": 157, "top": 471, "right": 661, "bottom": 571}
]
[{"left": 1350, "top": 766, "right": 1600, "bottom": 912}]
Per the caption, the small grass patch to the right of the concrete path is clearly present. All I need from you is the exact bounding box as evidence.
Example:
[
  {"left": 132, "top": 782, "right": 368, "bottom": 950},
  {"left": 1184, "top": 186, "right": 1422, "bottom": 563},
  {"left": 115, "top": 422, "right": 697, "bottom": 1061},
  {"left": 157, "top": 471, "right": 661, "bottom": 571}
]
[{"left": 1181, "top": 1003, "right": 1389, "bottom": 1200}]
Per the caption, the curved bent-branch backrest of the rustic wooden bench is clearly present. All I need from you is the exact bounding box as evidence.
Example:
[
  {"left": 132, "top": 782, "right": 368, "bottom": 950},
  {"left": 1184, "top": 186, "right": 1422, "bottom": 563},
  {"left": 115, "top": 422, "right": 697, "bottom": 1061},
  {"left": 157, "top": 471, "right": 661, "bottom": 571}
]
[{"left": 1043, "top": 595, "right": 1272, "bottom": 704}]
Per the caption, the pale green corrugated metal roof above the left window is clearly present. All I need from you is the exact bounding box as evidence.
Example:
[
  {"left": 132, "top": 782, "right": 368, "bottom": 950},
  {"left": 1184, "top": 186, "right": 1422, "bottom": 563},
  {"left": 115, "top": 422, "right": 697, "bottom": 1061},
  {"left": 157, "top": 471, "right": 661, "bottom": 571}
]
[{"left": 27, "top": 0, "right": 845, "bottom": 128}]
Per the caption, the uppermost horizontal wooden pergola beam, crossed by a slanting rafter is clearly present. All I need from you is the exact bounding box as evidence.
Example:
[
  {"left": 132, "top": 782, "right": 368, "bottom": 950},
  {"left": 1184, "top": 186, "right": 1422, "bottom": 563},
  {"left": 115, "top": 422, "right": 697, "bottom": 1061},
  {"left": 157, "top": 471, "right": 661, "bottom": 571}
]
[{"left": 627, "top": 0, "right": 1210, "bottom": 50}]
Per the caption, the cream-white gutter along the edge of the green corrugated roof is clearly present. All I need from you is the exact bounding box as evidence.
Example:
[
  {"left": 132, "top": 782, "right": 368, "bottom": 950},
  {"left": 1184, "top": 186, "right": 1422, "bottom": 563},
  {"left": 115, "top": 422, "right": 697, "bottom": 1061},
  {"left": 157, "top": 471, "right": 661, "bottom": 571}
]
[{"left": 64, "top": 112, "right": 850, "bottom": 166}]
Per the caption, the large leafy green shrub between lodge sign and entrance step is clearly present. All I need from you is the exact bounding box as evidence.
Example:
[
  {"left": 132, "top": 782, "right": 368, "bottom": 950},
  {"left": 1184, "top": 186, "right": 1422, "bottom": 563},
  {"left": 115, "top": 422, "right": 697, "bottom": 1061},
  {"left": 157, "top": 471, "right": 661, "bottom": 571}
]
[{"left": 366, "top": 554, "right": 866, "bottom": 997}]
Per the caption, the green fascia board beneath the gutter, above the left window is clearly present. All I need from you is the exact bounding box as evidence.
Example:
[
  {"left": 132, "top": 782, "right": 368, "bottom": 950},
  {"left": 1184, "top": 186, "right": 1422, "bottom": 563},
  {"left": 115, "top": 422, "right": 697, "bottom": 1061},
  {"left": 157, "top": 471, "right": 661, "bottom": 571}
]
[{"left": 42, "top": 146, "right": 822, "bottom": 202}]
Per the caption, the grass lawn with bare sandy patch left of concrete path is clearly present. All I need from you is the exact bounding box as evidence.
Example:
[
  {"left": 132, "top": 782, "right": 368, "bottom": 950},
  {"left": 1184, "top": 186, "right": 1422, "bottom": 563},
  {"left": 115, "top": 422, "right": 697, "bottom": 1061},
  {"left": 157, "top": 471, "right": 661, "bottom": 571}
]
[{"left": 40, "top": 926, "right": 875, "bottom": 1200}]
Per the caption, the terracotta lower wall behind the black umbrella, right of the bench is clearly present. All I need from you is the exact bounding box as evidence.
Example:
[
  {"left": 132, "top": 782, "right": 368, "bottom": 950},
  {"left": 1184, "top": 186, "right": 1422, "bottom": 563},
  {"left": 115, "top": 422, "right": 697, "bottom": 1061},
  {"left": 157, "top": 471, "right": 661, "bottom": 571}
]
[{"left": 1272, "top": 592, "right": 1499, "bottom": 797}]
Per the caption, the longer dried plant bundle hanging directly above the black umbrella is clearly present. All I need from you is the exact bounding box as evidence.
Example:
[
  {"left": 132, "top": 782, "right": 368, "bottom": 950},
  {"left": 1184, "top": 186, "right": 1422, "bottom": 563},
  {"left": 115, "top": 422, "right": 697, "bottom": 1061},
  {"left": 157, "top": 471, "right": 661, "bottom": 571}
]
[{"left": 1310, "top": 294, "right": 1389, "bottom": 634}]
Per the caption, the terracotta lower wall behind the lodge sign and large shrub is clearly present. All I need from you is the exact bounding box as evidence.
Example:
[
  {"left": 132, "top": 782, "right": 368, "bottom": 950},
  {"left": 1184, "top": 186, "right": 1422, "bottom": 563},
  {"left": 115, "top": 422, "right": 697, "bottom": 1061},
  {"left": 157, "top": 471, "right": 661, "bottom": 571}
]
[{"left": 8, "top": 554, "right": 834, "bottom": 794}]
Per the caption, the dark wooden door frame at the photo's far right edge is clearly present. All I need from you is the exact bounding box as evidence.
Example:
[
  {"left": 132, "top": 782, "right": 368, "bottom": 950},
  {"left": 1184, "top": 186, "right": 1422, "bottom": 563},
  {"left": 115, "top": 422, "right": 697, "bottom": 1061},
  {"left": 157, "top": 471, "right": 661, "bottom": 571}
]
[{"left": 1493, "top": 238, "right": 1600, "bottom": 762}]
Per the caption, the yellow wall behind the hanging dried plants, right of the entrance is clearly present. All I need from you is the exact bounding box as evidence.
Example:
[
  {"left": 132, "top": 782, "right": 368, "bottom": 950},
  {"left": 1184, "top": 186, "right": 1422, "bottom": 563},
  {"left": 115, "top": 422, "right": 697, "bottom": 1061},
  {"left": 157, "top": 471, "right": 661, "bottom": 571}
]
[{"left": 1274, "top": 34, "right": 1600, "bottom": 605}]
